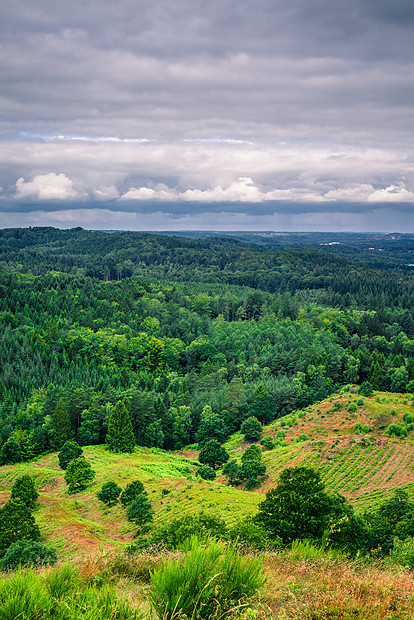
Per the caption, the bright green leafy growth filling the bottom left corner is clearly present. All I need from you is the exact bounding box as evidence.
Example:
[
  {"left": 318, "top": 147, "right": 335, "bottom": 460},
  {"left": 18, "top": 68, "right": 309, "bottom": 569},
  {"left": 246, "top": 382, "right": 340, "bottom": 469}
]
[{"left": 0, "top": 566, "right": 142, "bottom": 620}]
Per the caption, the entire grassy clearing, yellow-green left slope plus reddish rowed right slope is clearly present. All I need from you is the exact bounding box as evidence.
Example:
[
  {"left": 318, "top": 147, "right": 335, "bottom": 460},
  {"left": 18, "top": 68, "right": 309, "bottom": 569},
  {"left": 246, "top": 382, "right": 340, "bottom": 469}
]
[{"left": 0, "top": 393, "right": 414, "bottom": 557}]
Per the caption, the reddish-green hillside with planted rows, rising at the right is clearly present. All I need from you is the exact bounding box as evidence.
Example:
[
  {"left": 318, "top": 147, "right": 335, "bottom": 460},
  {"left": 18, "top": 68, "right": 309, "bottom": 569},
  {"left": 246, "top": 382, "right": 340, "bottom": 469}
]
[{"left": 227, "top": 392, "right": 414, "bottom": 509}]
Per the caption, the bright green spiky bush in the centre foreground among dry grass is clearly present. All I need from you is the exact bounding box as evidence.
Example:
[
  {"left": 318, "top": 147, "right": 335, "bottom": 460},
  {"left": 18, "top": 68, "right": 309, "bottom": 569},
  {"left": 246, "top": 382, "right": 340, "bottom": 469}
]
[{"left": 150, "top": 537, "right": 264, "bottom": 620}]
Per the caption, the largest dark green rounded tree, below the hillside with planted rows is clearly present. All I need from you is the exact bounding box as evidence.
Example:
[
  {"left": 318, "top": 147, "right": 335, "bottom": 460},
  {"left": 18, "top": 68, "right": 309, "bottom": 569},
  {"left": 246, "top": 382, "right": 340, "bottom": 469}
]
[{"left": 256, "top": 467, "right": 346, "bottom": 543}]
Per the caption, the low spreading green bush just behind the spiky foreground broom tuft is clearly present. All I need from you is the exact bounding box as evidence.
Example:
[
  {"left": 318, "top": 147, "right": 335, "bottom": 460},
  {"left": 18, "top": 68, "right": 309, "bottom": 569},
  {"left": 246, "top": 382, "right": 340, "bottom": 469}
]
[{"left": 150, "top": 512, "right": 227, "bottom": 549}]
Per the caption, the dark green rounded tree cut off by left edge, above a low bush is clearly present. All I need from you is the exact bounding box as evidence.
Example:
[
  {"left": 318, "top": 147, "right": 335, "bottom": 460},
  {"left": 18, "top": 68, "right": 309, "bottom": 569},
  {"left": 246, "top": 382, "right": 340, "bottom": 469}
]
[{"left": 0, "top": 499, "right": 40, "bottom": 556}]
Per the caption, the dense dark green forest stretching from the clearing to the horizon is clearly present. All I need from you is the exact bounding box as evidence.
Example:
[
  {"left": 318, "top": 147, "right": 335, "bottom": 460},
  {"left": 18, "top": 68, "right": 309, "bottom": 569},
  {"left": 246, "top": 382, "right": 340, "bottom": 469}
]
[{"left": 0, "top": 228, "right": 414, "bottom": 462}]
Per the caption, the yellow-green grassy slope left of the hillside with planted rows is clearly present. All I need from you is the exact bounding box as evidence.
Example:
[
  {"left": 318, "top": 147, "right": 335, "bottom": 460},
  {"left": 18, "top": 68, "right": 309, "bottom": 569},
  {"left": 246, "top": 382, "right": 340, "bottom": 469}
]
[{"left": 0, "top": 446, "right": 261, "bottom": 556}]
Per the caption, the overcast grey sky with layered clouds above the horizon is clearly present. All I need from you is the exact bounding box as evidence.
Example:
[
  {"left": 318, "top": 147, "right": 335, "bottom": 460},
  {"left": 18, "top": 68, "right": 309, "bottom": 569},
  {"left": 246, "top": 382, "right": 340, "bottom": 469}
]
[{"left": 0, "top": 0, "right": 414, "bottom": 232}]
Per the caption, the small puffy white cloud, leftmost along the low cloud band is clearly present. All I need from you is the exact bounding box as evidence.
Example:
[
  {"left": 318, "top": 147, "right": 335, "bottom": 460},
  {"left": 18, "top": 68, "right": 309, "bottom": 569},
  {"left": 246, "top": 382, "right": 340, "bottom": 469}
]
[{"left": 16, "top": 172, "right": 79, "bottom": 200}]
